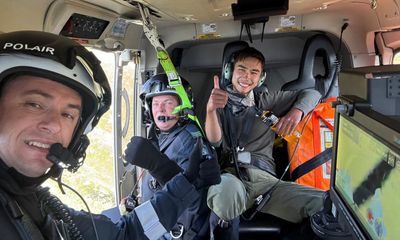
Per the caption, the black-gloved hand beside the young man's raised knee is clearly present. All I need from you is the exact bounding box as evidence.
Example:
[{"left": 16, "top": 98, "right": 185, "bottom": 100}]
[{"left": 183, "top": 138, "right": 221, "bottom": 189}]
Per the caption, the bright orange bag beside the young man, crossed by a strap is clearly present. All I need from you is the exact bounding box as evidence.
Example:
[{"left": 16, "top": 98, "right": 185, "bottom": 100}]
[{"left": 287, "top": 98, "right": 336, "bottom": 190}]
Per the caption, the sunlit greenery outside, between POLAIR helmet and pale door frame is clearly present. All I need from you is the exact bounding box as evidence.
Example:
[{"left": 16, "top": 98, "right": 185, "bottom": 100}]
[{"left": 43, "top": 50, "right": 115, "bottom": 213}]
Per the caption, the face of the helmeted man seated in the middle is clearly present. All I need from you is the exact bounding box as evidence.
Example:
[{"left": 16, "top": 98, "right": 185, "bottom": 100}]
[{"left": 151, "top": 95, "right": 179, "bottom": 132}]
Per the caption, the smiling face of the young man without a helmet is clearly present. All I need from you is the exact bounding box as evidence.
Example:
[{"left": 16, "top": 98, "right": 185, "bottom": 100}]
[{"left": 232, "top": 57, "right": 262, "bottom": 95}]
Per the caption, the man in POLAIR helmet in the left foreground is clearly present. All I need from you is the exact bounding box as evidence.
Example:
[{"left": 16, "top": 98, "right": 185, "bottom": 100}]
[{"left": 0, "top": 31, "right": 219, "bottom": 239}]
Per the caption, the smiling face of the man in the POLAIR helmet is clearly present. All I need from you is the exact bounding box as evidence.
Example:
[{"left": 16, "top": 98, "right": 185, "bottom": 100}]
[{"left": 0, "top": 76, "right": 82, "bottom": 177}]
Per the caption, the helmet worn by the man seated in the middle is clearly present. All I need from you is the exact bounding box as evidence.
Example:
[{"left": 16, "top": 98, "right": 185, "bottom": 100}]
[{"left": 140, "top": 73, "right": 193, "bottom": 120}]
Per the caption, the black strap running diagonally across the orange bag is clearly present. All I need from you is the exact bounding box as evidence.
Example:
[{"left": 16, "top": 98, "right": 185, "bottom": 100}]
[{"left": 291, "top": 147, "right": 332, "bottom": 181}]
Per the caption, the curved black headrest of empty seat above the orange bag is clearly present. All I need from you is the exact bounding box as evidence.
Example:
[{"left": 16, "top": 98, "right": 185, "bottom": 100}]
[{"left": 282, "top": 34, "right": 338, "bottom": 99}]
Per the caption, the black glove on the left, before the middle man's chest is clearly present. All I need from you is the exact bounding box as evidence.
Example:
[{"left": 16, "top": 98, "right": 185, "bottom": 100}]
[{"left": 125, "top": 136, "right": 182, "bottom": 185}]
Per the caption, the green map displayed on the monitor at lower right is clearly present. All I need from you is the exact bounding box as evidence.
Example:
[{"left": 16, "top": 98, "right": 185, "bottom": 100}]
[{"left": 334, "top": 115, "right": 400, "bottom": 239}]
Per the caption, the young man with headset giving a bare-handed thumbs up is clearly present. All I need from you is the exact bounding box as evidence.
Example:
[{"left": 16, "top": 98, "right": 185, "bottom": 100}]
[{"left": 205, "top": 47, "right": 323, "bottom": 239}]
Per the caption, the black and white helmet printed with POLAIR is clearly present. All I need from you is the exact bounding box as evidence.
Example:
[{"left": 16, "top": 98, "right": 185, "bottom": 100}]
[{"left": 0, "top": 31, "right": 111, "bottom": 170}]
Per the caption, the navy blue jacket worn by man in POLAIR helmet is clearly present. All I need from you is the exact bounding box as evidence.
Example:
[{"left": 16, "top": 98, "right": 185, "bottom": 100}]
[{"left": 0, "top": 160, "right": 199, "bottom": 240}]
